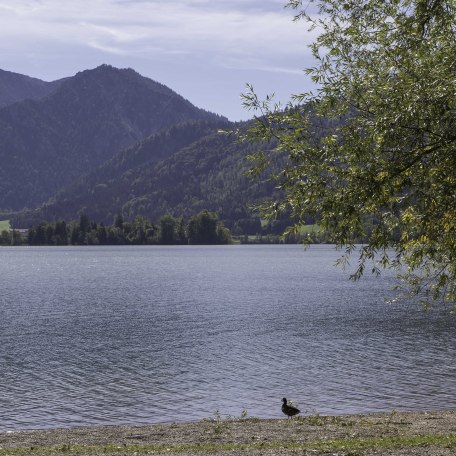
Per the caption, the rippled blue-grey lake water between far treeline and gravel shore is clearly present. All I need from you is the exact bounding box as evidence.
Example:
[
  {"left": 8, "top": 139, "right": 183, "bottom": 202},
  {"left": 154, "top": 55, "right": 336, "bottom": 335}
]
[{"left": 0, "top": 246, "right": 456, "bottom": 430}]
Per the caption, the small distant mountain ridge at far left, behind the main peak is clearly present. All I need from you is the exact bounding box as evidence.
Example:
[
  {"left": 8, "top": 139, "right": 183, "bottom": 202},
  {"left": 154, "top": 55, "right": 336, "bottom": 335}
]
[{"left": 0, "top": 70, "right": 64, "bottom": 109}]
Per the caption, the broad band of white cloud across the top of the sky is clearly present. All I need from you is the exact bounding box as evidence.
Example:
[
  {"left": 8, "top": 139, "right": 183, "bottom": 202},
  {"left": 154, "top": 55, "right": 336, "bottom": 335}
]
[{"left": 0, "top": 0, "right": 316, "bottom": 68}]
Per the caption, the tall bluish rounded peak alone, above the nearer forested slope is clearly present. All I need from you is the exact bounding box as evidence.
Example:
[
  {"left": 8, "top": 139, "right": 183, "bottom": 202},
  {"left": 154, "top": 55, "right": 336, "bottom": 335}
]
[{"left": 0, "top": 65, "right": 223, "bottom": 210}]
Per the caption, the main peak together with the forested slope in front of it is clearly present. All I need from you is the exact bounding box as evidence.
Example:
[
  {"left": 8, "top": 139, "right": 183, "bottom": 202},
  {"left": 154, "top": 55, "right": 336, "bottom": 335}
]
[{"left": 0, "top": 65, "right": 284, "bottom": 233}]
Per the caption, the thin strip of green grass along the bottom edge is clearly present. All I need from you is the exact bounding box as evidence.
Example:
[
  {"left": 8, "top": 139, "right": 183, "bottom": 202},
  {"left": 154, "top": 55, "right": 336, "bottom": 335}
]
[{"left": 0, "top": 434, "right": 456, "bottom": 456}]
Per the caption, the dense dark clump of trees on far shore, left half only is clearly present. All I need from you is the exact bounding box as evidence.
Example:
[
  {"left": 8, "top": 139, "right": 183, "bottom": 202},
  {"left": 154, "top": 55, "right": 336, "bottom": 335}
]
[{"left": 0, "top": 210, "right": 232, "bottom": 245}]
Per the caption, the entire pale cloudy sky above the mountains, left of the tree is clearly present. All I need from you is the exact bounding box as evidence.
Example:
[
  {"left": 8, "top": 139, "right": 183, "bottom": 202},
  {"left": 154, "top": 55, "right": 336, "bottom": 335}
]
[{"left": 0, "top": 0, "right": 314, "bottom": 120}]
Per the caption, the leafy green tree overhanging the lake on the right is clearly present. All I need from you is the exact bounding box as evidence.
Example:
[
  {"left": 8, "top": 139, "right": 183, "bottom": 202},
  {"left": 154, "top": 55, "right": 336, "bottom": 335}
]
[{"left": 244, "top": 0, "right": 456, "bottom": 304}]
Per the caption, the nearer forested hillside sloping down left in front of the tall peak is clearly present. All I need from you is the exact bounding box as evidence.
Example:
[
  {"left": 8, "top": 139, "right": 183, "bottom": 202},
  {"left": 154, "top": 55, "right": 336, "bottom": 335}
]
[{"left": 12, "top": 121, "right": 280, "bottom": 233}]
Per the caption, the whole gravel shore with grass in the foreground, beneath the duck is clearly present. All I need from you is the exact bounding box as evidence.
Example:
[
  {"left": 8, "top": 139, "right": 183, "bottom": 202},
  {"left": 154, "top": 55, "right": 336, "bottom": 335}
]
[{"left": 0, "top": 411, "right": 456, "bottom": 456}]
